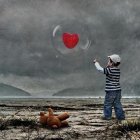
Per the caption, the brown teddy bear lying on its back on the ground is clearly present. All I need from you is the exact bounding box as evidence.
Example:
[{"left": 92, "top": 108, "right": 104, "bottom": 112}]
[{"left": 39, "top": 108, "right": 69, "bottom": 128}]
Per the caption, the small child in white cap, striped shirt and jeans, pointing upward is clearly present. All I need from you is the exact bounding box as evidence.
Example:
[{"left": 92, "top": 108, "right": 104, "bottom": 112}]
[{"left": 94, "top": 54, "right": 125, "bottom": 120}]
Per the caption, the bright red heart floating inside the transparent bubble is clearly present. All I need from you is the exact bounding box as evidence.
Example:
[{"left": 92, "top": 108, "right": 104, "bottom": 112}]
[{"left": 63, "top": 33, "right": 79, "bottom": 49}]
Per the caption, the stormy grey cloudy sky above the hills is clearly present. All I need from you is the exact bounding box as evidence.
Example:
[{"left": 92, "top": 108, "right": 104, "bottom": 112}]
[{"left": 0, "top": 0, "right": 140, "bottom": 96}]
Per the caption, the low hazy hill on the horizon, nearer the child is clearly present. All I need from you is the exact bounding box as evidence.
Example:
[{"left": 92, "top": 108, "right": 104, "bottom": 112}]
[{"left": 53, "top": 87, "right": 99, "bottom": 96}]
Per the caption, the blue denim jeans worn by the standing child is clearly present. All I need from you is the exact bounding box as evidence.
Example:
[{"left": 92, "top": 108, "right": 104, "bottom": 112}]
[{"left": 104, "top": 90, "right": 125, "bottom": 120}]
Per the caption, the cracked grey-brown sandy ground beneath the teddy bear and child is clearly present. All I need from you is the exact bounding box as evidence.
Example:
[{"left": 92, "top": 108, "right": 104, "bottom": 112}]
[{"left": 0, "top": 98, "right": 140, "bottom": 140}]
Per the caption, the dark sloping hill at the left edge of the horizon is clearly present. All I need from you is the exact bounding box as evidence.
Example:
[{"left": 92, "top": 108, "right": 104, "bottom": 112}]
[{"left": 0, "top": 83, "right": 30, "bottom": 96}]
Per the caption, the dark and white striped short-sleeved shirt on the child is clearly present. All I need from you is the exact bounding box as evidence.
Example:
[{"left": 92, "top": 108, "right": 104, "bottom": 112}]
[{"left": 103, "top": 67, "right": 121, "bottom": 91}]
